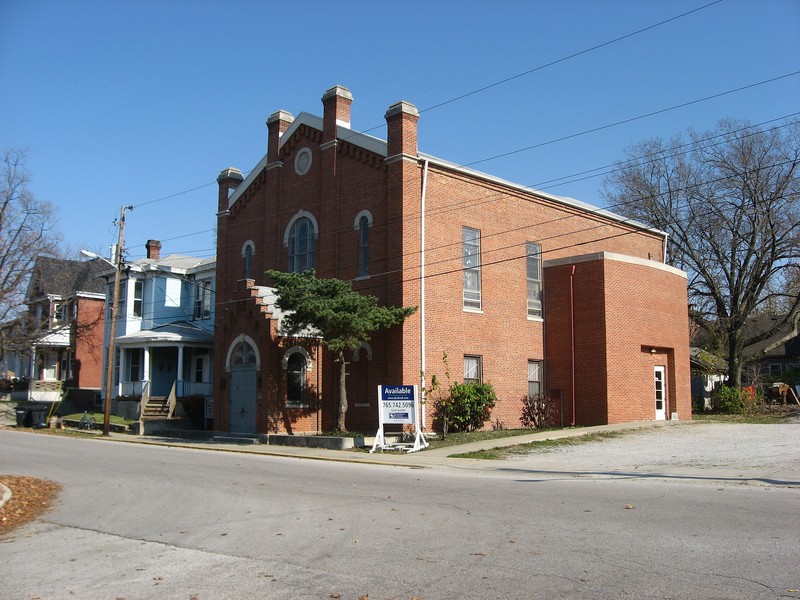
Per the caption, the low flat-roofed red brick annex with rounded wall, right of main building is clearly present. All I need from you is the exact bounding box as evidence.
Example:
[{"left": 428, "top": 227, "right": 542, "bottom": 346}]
[{"left": 545, "top": 255, "right": 691, "bottom": 425}]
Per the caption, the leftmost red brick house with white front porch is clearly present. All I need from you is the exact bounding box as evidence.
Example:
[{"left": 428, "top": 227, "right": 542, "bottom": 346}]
[{"left": 4, "top": 256, "right": 105, "bottom": 406}]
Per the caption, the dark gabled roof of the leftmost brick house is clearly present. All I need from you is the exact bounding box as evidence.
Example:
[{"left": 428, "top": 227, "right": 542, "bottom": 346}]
[{"left": 26, "top": 256, "right": 106, "bottom": 301}]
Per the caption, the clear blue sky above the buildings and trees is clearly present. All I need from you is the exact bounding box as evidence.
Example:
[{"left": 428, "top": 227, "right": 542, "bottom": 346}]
[{"left": 0, "top": 0, "right": 800, "bottom": 259}]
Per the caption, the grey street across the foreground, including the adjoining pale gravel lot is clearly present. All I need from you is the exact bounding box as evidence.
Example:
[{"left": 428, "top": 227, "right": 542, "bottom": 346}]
[{"left": 0, "top": 425, "right": 800, "bottom": 600}]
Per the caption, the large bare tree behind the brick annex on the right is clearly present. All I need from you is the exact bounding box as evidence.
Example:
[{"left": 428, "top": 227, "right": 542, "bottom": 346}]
[{"left": 605, "top": 120, "right": 800, "bottom": 386}]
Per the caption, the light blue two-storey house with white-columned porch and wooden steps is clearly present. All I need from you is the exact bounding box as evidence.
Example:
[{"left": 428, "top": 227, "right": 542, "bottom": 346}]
[{"left": 104, "top": 240, "right": 215, "bottom": 426}]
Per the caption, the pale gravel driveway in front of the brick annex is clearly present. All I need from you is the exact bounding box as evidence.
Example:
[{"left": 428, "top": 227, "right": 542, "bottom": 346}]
[{"left": 508, "top": 422, "right": 800, "bottom": 487}]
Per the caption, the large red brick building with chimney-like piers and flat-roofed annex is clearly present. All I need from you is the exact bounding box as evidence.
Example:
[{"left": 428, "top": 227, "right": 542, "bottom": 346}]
[{"left": 214, "top": 87, "right": 691, "bottom": 433}]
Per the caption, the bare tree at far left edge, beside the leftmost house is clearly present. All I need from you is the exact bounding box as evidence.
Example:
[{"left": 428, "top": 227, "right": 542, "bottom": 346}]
[{"left": 0, "top": 149, "right": 60, "bottom": 357}]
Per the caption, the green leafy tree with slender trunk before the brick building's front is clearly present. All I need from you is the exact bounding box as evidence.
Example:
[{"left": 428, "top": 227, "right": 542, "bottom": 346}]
[{"left": 267, "top": 270, "right": 417, "bottom": 431}]
